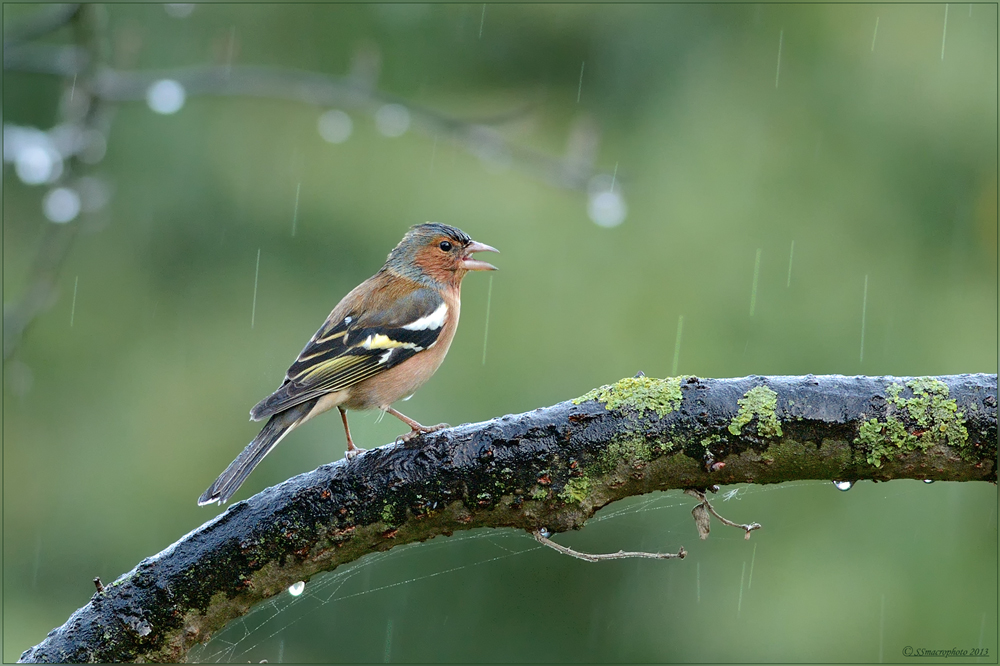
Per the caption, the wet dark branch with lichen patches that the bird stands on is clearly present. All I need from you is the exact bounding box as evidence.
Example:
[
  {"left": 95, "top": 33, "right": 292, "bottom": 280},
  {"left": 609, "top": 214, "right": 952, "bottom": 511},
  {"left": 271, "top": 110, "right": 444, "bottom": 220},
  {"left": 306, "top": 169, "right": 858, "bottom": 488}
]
[{"left": 22, "top": 375, "right": 997, "bottom": 662}]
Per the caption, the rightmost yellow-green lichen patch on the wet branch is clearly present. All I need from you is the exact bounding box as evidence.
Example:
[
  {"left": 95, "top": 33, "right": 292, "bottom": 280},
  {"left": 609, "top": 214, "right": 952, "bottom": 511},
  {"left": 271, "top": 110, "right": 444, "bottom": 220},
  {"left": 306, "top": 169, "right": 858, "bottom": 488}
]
[{"left": 854, "top": 377, "right": 969, "bottom": 467}]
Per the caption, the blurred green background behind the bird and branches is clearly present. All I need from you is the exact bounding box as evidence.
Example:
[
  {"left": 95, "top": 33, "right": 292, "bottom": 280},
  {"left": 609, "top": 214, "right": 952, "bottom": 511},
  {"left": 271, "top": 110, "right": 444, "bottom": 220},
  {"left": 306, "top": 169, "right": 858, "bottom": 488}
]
[{"left": 3, "top": 4, "right": 997, "bottom": 663}]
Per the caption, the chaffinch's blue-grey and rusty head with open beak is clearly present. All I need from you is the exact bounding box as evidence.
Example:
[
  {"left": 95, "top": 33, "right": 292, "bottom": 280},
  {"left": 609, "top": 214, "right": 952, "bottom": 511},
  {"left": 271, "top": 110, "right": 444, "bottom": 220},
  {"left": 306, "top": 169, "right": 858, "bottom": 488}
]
[{"left": 385, "top": 222, "right": 499, "bottom": 286}]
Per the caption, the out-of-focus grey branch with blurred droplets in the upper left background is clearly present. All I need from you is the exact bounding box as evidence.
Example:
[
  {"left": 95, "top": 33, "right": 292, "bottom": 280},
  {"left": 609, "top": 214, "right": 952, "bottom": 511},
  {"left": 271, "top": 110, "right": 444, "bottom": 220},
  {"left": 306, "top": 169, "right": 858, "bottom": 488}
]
[{"left": 4, "top": 43, "right": 608, "bottom": 358}]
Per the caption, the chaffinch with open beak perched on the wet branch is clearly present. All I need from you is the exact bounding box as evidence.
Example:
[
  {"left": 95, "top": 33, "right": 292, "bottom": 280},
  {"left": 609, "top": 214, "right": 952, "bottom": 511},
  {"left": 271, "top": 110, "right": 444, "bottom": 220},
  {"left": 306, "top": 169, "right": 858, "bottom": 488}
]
[{"left": 198, "top": 222, "right": 499, "bottom": 506}]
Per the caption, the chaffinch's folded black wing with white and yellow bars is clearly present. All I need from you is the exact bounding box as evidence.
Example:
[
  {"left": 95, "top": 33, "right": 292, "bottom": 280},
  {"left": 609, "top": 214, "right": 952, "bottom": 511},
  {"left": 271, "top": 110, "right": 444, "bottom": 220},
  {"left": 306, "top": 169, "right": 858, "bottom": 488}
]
[{"left": 250, "top": 287, "right": 448, "bottom": 421}]
